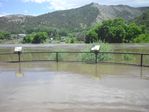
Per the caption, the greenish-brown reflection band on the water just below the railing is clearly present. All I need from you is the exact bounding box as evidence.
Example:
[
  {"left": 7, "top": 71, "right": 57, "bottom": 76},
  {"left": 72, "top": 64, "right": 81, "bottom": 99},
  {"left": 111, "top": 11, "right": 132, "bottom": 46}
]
[{"left": 0, "top": 62, "right": 149, "bottom": 79}]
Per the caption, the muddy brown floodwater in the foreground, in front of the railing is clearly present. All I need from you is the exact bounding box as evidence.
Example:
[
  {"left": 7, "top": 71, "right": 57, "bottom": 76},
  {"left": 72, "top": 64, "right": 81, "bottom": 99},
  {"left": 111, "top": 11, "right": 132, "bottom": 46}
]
[{"left": 0, "top": 62, "right": 149, "bottom": 112}]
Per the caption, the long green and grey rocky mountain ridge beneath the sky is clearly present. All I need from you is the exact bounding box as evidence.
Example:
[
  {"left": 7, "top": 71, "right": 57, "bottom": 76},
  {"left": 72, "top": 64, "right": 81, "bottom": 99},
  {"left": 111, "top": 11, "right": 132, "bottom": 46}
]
[{"left": 0, "top": 3, "right": 149, "bottom": 33}]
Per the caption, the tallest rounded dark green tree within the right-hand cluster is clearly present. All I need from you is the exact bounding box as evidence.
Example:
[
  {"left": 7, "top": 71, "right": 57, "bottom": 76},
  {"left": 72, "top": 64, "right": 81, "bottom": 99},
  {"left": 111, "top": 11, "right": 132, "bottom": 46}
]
[{"left": 98, "top": 18, "right": 126, "bottom": 43}]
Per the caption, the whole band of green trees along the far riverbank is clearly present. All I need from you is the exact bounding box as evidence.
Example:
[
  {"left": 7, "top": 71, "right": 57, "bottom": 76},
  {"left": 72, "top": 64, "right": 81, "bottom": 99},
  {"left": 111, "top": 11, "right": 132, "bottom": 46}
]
[{"left": 0, "top": 18, "right": 149, "bottom": 43}]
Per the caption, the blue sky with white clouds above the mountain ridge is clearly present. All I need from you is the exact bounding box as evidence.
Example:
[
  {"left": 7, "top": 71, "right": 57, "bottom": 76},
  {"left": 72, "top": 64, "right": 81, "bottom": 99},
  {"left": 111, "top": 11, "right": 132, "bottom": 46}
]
[{"left": 0, "top": 0, "right": 149, "bottom": 16}]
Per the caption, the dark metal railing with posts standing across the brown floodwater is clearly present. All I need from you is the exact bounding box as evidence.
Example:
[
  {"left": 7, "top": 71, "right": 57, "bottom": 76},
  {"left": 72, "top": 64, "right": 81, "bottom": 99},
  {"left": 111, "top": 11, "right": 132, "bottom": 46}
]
[{"left": 0, "top": 52, "right": 149, "bottom": 66}]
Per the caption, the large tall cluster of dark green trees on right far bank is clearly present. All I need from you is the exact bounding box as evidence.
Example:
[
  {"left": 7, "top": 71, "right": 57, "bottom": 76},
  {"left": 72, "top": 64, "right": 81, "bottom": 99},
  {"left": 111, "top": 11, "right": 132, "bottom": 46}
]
[{"left": 85, "top": 18, "right": 149, "bottom": 43}]
